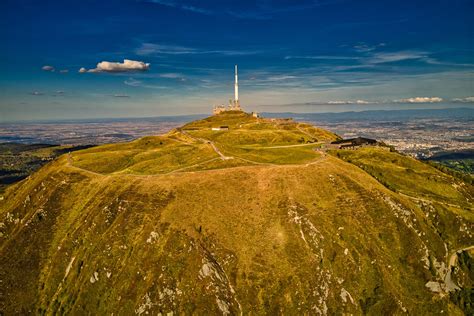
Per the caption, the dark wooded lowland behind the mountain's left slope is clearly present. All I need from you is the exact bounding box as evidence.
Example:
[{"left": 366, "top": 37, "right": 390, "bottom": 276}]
[{"left": 0, "top": 143, "right": 95, "bottom": 193}]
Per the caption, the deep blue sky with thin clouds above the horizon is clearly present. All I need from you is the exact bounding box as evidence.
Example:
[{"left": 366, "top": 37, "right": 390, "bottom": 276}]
[{"left": 0, "top": 0, "right": 474, "bottom": 121}]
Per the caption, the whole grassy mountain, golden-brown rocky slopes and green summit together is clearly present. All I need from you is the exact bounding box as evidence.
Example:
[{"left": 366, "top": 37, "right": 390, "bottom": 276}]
[{"left": 0, "top": 112, "right": 474, "bottom": 315}]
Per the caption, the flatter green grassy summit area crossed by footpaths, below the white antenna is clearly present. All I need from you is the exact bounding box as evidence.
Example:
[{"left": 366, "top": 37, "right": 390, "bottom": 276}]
[{"left": 71, "top": 112, "right": 337, "bottom": 175}]
